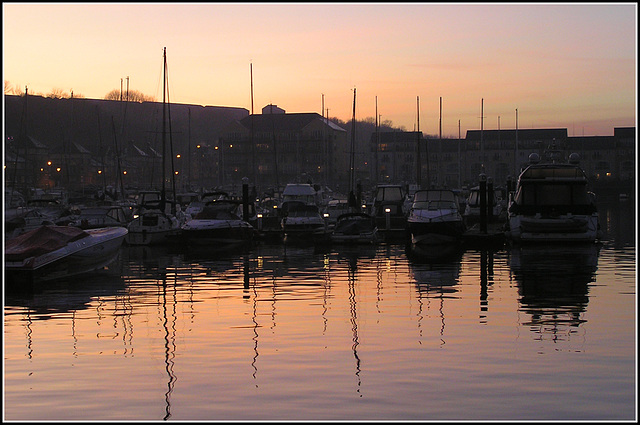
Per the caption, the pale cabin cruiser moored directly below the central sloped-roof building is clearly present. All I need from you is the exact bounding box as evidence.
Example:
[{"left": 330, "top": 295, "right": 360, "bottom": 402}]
[{"left": 281, "top": 201, "right": 331, "bottom": 242}]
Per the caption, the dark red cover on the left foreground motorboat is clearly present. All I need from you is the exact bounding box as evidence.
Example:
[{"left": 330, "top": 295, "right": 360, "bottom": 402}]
[{"left": 4, "top": 226, "right": 89, "bottom": 261}]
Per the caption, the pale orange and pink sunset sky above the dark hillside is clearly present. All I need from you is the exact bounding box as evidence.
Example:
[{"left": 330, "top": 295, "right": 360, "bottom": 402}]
[{"left": 2, "top": 3, "right": 638, "bottom": 138}]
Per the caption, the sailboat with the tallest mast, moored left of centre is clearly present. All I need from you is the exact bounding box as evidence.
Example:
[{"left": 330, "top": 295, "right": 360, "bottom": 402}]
[{"left": 126, "top": 47, "right": 184, "bottom": 245}]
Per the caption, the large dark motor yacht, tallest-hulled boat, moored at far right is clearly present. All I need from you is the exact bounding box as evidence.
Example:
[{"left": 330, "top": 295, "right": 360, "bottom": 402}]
[{"left": 505, "top": 149, "right": 601, "bottom": 243}]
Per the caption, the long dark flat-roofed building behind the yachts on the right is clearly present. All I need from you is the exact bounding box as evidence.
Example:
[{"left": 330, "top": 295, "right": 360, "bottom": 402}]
[{"left": 371, "top": 127, "right": 636, "bottom": 190}]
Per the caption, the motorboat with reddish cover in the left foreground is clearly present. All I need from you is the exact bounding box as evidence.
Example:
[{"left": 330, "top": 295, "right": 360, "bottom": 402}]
[{"left": 4, "top": 225, "right": 127, "bottom": 282}]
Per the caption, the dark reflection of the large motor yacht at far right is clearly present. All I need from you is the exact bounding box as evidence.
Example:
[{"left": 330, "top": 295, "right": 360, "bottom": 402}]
[{"left": 510, "top": 244, "right": 600, "bottom": 341}]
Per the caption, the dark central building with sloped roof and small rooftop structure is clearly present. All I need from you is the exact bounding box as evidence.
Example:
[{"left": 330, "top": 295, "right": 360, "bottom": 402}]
[{"left": 220, "top": 105, "right": 349, "bottom": 190}]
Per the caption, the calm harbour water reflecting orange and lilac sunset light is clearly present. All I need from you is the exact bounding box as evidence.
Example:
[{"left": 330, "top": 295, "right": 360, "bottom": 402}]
[{"left": 4, "top": 197, "right": 637, "bottom": 421}]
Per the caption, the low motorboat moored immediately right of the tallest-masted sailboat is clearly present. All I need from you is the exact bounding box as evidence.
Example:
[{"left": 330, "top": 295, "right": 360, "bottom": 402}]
[{"left": 180, "top": 199, "right": 256, "bottom": 248}]
